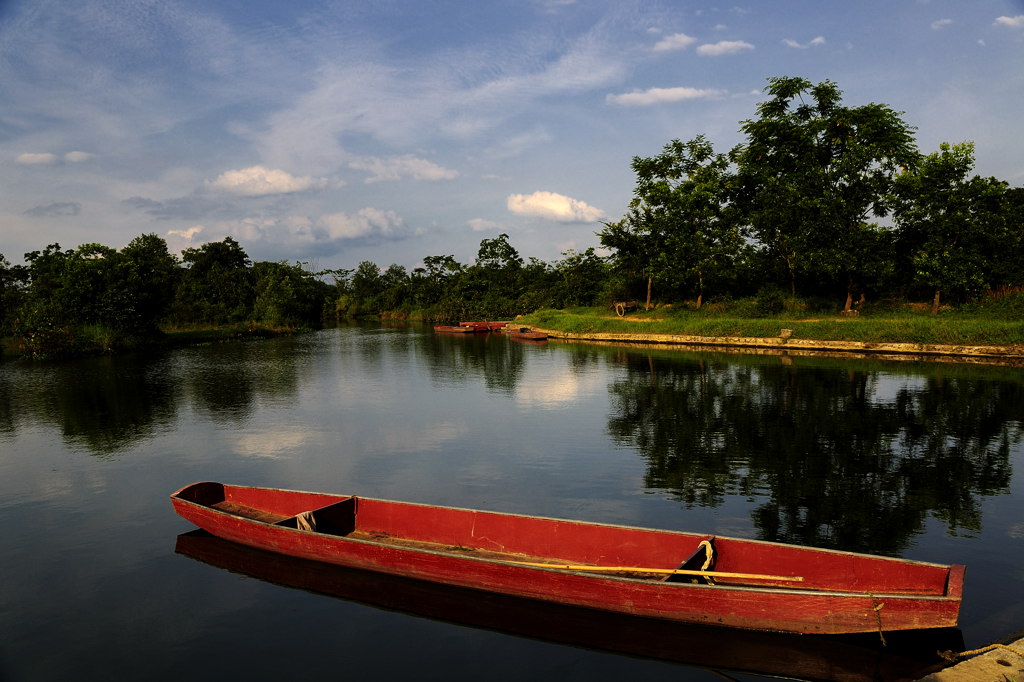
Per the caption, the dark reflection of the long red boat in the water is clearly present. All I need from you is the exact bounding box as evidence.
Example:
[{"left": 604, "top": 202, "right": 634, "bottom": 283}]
[{"left": 175, "top": 530, "right": 964, "bottom": 681}]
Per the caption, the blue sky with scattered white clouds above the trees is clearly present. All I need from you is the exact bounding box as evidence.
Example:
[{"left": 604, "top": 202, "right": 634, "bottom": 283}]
[{"left": 0, "top": 0, "right": 1024, "bottom": 271}]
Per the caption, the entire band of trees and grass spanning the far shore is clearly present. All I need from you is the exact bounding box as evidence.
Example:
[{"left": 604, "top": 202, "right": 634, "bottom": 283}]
[{"left": 0, "top": 78, "right": 1024, "bottom": 357}]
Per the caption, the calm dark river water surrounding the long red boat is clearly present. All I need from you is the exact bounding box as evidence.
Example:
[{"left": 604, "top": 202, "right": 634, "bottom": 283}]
[{"left": 0, "top": 326, "right": 1024, "bottom": 682}]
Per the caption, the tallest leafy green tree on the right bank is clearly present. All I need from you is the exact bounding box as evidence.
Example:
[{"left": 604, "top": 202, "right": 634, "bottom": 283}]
[{"left": 733, "top": 77, "right": 920, "bottom": 310}]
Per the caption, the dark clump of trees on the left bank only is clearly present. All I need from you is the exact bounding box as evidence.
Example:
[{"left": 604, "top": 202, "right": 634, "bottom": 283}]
[{"left": 0, "top": 235, "right": 332, "bottom": 356}]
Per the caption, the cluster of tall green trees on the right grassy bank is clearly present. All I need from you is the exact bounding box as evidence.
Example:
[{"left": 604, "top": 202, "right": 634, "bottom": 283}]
[{"left": 599, "top": 78, "right": 1024, "bottom": 312}]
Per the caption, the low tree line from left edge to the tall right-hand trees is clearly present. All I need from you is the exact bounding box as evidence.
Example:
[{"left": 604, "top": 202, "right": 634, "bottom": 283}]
[{"left": 0, "top": 229, "right": 609, "bottom": 357}]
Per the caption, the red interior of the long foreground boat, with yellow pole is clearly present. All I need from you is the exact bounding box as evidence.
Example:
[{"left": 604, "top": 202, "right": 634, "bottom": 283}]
[{"left": 178, "top": 483, "right": 963, "bottom": 596}]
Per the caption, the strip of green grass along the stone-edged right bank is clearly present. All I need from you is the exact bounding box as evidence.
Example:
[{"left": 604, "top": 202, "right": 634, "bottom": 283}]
[{"left": 518, "top": 306, "right": 1024, "bottom": 346}]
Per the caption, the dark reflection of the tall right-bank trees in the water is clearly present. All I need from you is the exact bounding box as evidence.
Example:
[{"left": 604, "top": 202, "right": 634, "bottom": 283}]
[{"left": 608, "top": 353, "right": 1024, "bottom": 555}]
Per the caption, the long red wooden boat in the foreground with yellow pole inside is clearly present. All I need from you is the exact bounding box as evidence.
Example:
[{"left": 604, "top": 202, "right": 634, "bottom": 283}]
[{"left": 171, "top": 482, "right": 965, "bottom": 634}]
